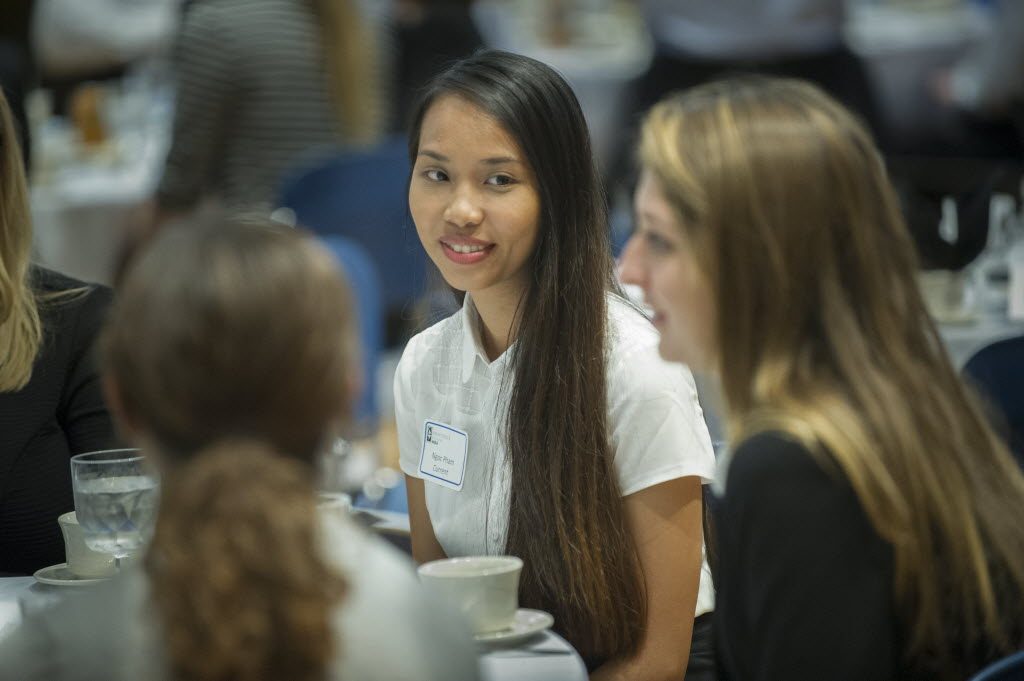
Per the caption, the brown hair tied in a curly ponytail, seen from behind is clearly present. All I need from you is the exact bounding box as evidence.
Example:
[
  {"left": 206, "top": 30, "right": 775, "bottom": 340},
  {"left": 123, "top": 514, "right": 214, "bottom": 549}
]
[{"left": 102, "top": 219, "right": 352, "bottom": 681}]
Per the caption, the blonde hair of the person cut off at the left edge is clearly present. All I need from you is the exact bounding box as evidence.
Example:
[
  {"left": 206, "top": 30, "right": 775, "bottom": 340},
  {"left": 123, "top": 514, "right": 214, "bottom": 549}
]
[{"left": 0, "top": 91, "right": 43, "bottom": 392}]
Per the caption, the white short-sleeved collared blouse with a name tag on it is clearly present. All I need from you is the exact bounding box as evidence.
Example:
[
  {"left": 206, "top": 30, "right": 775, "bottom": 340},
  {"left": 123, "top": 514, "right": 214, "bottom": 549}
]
[{"left": 394, "top": 295, "right": 715, "bottom": 614}]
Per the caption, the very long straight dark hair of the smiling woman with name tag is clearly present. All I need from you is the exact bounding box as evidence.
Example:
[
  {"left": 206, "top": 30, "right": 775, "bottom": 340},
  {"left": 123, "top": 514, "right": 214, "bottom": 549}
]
[{"left": 410, "top": 51, "right": 646, "bottom": 657}]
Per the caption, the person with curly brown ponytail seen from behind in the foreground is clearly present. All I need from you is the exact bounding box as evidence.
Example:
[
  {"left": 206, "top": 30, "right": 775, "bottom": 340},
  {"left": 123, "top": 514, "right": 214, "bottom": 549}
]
[{"left": 0, "top": 219, "right": 477, "bottom": 681}]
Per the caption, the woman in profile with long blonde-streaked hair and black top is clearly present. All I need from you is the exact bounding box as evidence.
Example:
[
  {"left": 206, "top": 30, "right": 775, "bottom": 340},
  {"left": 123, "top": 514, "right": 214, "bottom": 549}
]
[{"left": 623, "top": 79, "right": 1024, "bottom": 681}]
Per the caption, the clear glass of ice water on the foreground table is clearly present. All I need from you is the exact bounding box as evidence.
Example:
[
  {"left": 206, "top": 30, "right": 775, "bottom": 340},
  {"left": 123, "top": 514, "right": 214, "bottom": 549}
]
[{"left": 71, "top": 450, "right": 160, "bottom": 566}]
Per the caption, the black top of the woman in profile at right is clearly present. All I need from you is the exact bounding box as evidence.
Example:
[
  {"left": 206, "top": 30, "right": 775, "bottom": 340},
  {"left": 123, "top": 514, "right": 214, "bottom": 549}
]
[{"left": 715, "top": 433, "right": 913, "bottom": 681}]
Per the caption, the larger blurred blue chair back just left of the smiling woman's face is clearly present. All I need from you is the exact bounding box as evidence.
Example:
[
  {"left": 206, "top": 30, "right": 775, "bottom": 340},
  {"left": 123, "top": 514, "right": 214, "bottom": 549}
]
[{"left": 279, "top": 138, "right": 427, "bottom": 319}]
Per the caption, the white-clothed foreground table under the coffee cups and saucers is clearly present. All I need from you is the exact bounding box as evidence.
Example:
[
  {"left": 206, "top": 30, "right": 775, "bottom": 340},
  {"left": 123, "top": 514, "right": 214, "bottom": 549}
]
[{"left": 0, "top": 577, "right": 587, "bottom": 681}]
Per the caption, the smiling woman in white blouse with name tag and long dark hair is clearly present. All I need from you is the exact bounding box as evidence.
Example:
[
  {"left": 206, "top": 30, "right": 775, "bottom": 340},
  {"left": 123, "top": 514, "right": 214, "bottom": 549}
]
[{"left": 395, "top": 51, "right": 714, "bottom": 680}]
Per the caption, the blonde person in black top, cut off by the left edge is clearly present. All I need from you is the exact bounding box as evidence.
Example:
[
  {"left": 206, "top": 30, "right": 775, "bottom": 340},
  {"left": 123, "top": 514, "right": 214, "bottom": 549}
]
[{"left": 0, "top": 87, "right": 116, "bottom": 574}]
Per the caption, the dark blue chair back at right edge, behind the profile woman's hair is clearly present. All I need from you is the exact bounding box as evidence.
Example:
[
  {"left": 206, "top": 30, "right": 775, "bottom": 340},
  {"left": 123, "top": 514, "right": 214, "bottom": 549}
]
[{"left": 964, "top": 336, "right": 1024, "bottom": 467}]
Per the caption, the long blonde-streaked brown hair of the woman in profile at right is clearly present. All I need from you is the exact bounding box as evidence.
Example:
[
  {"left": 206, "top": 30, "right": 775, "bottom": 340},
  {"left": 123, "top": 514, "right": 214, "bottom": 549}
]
[{"left": 640, "top": 79, "right": 1024, "bottom": 678}]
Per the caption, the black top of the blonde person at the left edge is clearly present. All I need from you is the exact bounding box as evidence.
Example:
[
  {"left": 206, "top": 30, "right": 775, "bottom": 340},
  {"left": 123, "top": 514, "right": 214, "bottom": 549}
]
[{"left": 0, "top": 268, "right": 117, "bottom": 574}]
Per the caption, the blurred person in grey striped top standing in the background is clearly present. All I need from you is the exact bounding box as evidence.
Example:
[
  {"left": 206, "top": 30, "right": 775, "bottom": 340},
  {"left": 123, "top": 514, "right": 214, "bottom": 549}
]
[{"left": 156, "top": 0, "right": 387, "bottom": 215}]
